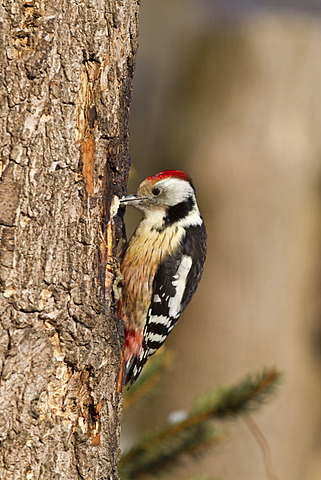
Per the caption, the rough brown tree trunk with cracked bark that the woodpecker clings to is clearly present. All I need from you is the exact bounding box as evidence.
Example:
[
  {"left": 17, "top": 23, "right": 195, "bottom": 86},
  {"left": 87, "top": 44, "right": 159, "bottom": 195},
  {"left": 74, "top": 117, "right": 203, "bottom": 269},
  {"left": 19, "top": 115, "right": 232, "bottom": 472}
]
[{"left": 0, "top": 0, "right": 138, "bottom": 480}]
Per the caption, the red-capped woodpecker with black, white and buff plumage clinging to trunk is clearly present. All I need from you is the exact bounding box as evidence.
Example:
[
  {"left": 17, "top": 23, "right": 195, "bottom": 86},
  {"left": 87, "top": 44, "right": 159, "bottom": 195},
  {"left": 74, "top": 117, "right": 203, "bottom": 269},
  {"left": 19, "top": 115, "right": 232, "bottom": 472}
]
[{"left": 118, "top": 170, "right": 206, "bottom": 386}]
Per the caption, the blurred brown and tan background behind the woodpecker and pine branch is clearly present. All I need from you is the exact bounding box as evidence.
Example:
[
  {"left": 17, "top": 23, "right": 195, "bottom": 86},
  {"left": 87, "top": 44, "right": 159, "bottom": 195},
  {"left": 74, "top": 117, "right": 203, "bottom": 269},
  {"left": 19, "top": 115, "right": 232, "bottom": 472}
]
[{"left": 125, "top": 0, "right": 321, "bottom": 480}]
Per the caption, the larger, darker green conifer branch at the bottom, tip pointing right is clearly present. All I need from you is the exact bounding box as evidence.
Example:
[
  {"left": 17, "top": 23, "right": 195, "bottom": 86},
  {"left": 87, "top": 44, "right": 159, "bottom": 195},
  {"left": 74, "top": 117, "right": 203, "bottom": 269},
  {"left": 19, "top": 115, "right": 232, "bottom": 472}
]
[{"left": 119, "top": 369, "right": 280, "bottom": 480}]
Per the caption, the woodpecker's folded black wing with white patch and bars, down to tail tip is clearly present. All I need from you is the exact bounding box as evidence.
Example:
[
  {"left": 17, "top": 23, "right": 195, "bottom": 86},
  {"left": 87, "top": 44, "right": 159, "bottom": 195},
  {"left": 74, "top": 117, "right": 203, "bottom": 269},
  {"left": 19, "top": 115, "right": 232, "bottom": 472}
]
[{"left": 125, "top": 224, "right": 206, "bottom": 384}]
